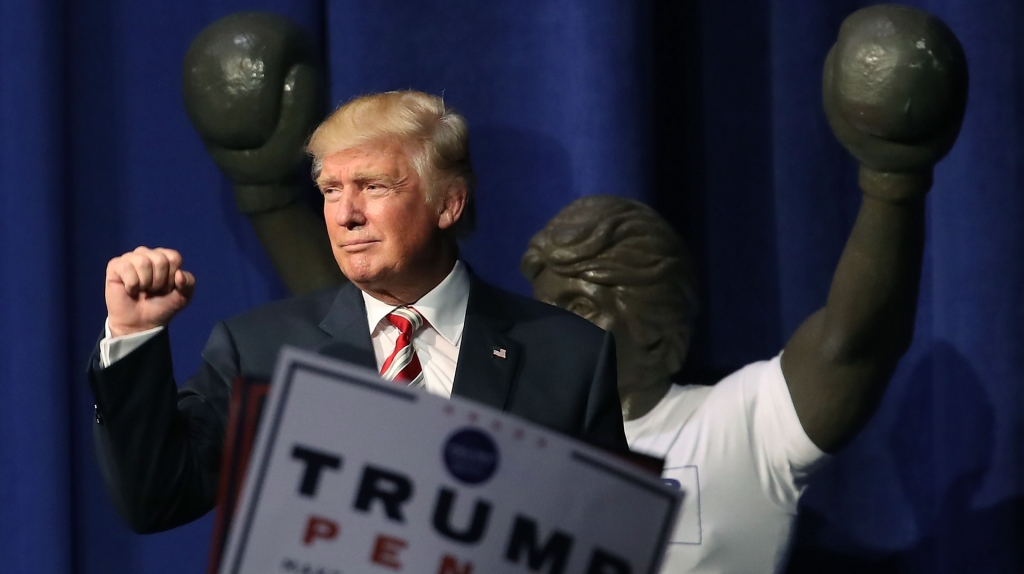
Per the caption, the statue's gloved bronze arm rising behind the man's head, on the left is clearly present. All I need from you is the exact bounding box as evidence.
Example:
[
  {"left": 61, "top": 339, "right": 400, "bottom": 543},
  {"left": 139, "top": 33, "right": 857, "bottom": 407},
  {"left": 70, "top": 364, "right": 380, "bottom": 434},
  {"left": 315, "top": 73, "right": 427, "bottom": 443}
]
[{"left": 182, "top": 12, "right": 345, "bottom": 294}]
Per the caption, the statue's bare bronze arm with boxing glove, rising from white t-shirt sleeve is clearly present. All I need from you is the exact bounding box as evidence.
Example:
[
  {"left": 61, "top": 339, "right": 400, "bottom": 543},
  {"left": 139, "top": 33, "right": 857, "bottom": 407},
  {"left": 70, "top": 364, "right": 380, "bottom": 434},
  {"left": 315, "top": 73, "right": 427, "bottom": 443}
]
[{"left": 782, "top": 5, "right": 968, "bottom": 451}]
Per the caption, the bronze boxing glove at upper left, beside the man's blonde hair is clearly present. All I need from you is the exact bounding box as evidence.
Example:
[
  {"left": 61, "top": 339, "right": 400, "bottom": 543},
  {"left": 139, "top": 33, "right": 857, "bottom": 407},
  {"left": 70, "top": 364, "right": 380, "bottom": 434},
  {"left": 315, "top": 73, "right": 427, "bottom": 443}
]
[{"left": 182, "top": 12, "right": 321, "bottom": 185}]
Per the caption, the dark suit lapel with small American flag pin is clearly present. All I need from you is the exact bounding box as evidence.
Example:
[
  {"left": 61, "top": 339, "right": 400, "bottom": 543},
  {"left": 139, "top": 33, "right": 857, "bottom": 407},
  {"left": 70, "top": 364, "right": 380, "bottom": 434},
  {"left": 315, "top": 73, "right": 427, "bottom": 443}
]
[{"left": 452, "top": 273, "right": 521, "bottom": 409}]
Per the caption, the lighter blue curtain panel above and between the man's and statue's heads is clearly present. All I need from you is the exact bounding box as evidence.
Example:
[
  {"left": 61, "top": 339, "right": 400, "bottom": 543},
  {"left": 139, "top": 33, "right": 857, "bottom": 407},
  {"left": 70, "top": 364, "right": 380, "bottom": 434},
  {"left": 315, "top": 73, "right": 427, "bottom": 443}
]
[{"left": 327, "top": 0, "right": 651, "bottom": 293}]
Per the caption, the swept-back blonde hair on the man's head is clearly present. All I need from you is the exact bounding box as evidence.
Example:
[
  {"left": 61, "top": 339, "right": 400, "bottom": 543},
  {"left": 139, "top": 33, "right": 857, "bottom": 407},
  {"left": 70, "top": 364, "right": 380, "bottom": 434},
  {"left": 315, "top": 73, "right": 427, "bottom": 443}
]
[{"left": 306, "top": 90, "right": 476, "bottom": 237}]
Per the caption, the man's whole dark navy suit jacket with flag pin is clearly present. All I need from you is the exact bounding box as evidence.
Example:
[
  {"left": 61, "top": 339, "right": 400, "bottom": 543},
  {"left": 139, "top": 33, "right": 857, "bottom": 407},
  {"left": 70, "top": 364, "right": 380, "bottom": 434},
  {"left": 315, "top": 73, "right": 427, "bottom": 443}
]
[{"left": 89, "top": 275, "right": 627, "bottom": 532}]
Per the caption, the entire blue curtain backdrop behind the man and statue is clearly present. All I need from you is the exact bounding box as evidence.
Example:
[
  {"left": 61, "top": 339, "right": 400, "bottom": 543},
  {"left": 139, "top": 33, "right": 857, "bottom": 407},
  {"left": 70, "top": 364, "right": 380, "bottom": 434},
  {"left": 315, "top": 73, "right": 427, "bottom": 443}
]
[{"left": 0, "top": 0, "right": 1024, "bottom": 574}]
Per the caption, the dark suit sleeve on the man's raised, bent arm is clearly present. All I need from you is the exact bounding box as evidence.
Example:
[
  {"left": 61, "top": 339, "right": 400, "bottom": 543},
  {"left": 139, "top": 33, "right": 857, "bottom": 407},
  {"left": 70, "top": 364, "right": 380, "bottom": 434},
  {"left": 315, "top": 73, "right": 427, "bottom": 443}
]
[{"left": 88, "top": 324, "right": 237, "bottom": 533}]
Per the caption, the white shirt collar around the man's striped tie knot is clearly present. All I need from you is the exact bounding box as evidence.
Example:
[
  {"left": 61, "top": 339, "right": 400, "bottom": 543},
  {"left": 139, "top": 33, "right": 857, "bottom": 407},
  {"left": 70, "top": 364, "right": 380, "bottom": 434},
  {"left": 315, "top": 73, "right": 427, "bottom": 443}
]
[{"left": 362, "top": 261, "right": 469, "bottom": 345}]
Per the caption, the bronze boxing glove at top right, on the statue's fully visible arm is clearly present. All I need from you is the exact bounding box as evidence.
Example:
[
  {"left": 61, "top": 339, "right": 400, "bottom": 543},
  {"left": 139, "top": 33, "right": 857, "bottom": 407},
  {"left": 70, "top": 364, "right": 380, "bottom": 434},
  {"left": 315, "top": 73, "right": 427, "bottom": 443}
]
[{"left": 822, "top": 4, "right": 968, "bottom": 173}]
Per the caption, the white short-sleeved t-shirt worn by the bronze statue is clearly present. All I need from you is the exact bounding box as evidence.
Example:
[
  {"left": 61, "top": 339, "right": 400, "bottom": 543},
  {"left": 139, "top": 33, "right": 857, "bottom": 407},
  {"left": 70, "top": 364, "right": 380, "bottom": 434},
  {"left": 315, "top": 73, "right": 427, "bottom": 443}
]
[{"left": 626, "top": 356, "right": 827, "bottom": 574}]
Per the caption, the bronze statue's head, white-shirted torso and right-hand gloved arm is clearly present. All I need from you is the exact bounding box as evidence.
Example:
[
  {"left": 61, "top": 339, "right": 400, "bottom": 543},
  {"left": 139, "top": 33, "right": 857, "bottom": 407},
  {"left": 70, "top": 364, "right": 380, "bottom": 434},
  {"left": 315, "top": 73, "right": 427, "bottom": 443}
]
[{"left": 521, "top": 5, "right": 968, "bottom": 572}]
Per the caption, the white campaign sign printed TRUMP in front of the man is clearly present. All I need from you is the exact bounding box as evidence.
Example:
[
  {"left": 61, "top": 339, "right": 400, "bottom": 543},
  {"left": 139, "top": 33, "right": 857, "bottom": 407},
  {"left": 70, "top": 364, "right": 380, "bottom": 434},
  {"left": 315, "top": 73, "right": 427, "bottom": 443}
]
[{"left": 220, "top": 349, "right": 682, "bottom": 574}]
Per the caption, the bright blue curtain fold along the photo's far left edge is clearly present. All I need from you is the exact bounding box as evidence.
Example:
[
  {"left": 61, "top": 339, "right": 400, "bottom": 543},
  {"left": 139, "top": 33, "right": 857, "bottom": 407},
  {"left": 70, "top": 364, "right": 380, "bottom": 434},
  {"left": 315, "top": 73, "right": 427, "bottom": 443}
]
[{"left": 0, "top": 1, "right": 75, "bottom": 572}]
